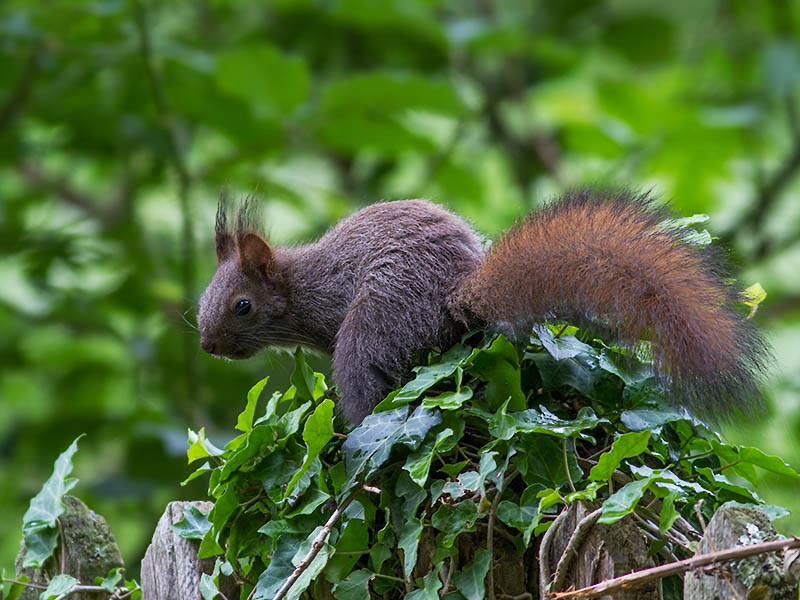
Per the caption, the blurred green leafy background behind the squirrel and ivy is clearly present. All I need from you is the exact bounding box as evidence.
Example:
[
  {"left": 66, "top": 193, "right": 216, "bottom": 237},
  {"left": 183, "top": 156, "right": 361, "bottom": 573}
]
[{"left": 0, "top": 0, "right": 800, "bottom": 576}]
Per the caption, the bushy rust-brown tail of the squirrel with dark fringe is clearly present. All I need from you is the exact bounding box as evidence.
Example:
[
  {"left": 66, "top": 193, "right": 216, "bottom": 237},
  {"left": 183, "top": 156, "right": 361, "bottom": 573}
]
[{"left": 455, "top": 190, "right": 769, "bottom": 417}]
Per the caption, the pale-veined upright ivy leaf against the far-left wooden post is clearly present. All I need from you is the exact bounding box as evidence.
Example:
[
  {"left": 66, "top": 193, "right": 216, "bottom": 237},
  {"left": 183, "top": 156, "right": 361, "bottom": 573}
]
[{"left": 22, "top": 434, "right": 83, "bottom": 568}]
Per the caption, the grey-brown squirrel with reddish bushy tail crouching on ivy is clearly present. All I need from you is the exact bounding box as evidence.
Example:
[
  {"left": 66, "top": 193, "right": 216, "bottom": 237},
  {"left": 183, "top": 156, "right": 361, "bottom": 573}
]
[{"left": 198, "top": 189, "right": 769, "bottom": 424}]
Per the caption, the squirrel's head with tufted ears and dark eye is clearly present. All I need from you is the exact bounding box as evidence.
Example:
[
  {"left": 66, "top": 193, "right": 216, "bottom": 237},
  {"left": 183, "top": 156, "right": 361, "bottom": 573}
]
[{"left": 197, "top": 196, "right": 287, "bottom": 359}]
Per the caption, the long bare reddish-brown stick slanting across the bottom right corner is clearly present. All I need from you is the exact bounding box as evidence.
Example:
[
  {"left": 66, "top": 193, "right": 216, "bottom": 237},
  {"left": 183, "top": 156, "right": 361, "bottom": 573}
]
[{"left": 548, "top": 537, "right": 800, "bottom": 600}]
